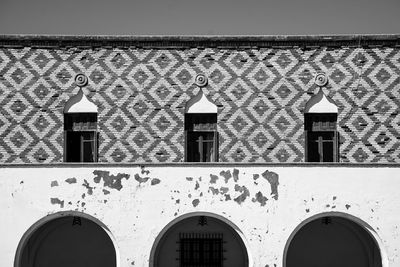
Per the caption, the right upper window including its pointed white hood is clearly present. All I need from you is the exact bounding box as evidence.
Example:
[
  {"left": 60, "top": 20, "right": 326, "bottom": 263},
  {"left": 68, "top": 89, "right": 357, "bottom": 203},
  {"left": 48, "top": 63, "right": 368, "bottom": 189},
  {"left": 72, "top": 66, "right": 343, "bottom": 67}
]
[{"left": 304, "top": 89, "right": 339, "bottom": 162}]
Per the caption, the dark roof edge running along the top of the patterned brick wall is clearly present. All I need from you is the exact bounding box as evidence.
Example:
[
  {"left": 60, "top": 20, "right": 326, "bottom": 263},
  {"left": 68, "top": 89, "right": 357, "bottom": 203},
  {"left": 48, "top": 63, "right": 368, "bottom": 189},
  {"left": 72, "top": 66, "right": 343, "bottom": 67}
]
[{"left": 0, "top": 34, "right": 400, "bottom": 47}]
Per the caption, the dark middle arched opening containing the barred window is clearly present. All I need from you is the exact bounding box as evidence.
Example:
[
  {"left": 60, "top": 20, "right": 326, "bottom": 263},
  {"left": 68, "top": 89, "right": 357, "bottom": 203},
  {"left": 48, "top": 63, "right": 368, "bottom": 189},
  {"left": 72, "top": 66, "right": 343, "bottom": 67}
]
[{"left": 150, "top": 214, "right": 249, "bottom": 267}]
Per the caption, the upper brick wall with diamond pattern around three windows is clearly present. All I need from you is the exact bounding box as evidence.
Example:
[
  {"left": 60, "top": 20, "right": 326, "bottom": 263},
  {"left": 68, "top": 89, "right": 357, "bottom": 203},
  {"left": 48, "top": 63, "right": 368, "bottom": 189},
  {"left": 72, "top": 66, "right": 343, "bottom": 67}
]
[{"left": 0, "top": 37, "right": 400, "bottom": 163}]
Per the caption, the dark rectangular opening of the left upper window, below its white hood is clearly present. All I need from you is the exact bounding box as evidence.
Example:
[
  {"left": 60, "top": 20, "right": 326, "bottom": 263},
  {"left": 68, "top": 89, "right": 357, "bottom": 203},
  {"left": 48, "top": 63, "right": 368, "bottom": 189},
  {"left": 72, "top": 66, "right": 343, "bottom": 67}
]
[{"left": 64, "top": 113, "right": 98, "bottom": 162}]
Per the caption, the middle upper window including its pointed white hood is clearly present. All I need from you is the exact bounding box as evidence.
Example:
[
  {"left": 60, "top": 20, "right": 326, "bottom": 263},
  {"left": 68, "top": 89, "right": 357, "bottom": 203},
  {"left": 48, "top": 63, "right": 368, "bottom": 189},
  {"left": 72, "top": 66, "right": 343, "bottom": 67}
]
[{"left": 185, "top": 90, "right": 218, "bottom": 162}]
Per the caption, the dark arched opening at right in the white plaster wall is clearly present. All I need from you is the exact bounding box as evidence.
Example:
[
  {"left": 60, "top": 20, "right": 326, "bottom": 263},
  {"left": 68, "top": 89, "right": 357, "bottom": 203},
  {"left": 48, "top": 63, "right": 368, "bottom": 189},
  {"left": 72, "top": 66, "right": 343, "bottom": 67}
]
[{"left": 284, "top": 214, "right": 384, "bottom": 267}]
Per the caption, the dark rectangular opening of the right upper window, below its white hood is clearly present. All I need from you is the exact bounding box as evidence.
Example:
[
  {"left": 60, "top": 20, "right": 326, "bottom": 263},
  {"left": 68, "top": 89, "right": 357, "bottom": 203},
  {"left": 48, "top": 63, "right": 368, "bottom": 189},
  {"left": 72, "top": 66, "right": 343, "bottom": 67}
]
[{"left": 305, "top": 113, "right": 339, "bottom": 162}]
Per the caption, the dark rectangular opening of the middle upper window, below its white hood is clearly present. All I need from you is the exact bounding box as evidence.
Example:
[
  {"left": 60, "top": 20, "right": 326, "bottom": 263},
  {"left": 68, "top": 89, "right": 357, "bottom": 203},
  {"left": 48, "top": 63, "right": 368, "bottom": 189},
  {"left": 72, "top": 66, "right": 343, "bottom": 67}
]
[{"left": 185, "top": 114, "right": 218, "bottom": 162}]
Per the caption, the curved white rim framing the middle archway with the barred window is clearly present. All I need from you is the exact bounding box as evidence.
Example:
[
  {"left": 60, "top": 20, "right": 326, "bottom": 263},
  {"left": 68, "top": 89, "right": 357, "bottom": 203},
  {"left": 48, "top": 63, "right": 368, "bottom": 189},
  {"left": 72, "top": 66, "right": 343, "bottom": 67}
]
[{"left": 149, "top": 211, "right": 254, "bottom": 267}]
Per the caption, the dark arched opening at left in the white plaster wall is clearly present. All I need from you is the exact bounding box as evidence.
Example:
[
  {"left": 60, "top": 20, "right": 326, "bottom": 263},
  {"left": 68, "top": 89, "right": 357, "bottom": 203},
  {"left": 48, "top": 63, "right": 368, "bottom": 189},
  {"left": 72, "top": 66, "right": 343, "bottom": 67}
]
[{"left": 15, "top": 214, "right": 117, "bottom": 267}]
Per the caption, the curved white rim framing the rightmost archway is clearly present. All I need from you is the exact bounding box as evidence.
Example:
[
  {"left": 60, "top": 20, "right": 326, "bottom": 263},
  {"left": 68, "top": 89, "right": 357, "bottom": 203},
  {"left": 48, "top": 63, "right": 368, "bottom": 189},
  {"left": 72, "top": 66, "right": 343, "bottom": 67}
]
[{"left": 282, "top": 211, "right": 389, "bottom": 267}]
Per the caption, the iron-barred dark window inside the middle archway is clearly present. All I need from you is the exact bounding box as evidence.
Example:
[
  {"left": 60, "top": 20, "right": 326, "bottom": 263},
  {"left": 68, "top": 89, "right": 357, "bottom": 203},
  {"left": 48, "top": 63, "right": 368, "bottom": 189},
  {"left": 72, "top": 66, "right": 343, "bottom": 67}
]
[{"left": 179, "top": 233, "right": 224, "bottom": 267}]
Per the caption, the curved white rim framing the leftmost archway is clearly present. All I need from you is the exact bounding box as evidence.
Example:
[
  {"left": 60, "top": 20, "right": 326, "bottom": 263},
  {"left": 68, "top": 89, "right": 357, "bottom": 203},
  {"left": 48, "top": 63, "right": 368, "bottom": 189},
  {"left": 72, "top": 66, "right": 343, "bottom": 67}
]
[{"left": 14, "top": 211, "right": 121, "bottom": 267}]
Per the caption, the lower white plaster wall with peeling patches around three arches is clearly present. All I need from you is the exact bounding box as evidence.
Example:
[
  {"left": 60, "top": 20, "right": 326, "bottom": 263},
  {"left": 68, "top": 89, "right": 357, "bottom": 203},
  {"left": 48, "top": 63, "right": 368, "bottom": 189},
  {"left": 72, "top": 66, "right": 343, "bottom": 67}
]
[{"left": 0, "top": 165, "right": 400, "bottom": 267}]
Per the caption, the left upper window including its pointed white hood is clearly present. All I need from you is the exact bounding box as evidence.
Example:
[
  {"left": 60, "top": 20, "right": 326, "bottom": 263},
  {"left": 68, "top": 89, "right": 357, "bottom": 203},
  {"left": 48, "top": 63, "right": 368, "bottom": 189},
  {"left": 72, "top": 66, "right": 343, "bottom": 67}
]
[{"left": 64, "top": 89, "right": 98, "bottom": 162}]
